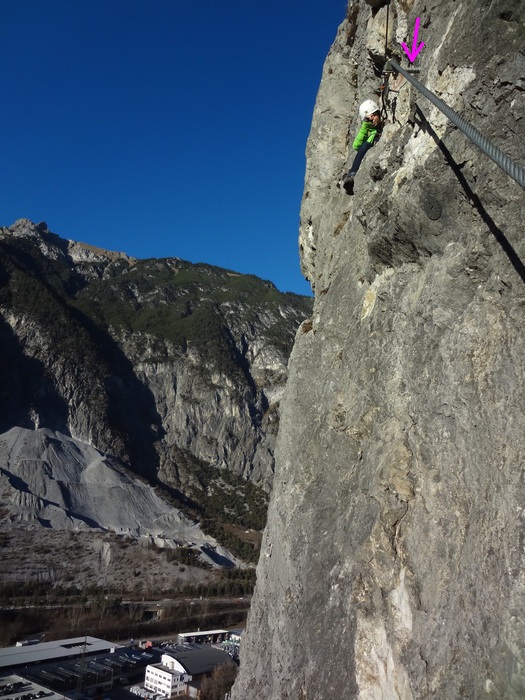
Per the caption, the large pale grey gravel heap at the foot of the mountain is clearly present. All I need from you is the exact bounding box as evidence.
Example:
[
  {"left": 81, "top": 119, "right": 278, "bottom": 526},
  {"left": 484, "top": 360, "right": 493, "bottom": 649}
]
[{"left": 0, "top": 427, "right": 236, "bottom": 562}]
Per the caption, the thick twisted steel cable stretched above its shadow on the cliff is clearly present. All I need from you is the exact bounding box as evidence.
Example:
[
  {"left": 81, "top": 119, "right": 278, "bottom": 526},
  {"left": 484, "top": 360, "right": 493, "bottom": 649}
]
[{"left": 385, "top": 58, "right": 525, "bottom": 188}]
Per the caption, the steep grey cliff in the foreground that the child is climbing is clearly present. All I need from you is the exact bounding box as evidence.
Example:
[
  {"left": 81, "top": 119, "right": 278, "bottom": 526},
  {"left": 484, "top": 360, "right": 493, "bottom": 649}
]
[{"left": 232, "top": 0, "right": 525, "bottom": 700}]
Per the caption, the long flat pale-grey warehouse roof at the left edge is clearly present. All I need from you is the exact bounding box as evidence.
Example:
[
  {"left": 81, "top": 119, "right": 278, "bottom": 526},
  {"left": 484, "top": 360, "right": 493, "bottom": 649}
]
[{"left": 0, "top": 637, "right": 120, "bottom": 670}]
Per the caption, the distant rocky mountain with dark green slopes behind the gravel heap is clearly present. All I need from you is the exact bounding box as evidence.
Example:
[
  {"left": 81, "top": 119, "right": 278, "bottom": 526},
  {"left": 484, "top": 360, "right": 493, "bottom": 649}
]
[{"left": 0, "top": 219, "right": 311, "bottom": 552}]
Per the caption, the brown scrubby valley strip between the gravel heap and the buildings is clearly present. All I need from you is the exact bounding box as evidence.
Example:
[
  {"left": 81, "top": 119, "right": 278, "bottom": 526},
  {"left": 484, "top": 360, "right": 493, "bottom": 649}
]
[{"left": 0, "top": 529, "right": 255, "bottom": 646}]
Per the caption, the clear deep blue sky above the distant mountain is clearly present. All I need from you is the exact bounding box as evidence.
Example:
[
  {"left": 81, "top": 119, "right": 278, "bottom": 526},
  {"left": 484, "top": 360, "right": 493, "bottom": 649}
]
[{"left": 0, "top": 0, "right": 346, "bottom": 294}]
